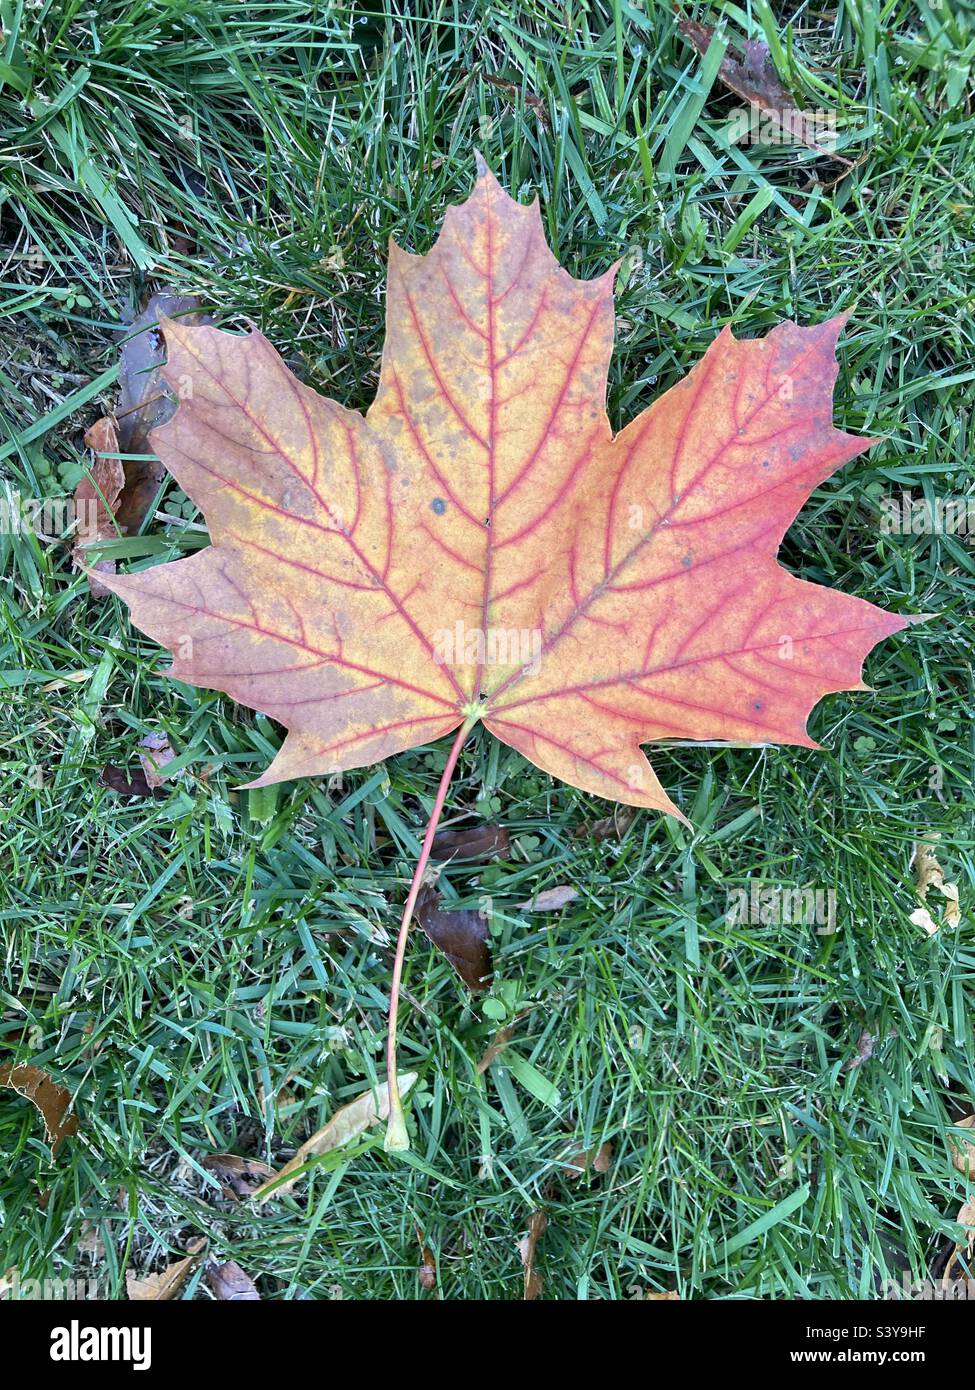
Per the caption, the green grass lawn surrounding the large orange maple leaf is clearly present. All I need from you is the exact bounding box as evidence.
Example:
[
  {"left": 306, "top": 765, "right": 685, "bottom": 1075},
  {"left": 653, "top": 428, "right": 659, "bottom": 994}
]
[{"left": 0, "top": 0, "right": 975, "bottom": 1300}]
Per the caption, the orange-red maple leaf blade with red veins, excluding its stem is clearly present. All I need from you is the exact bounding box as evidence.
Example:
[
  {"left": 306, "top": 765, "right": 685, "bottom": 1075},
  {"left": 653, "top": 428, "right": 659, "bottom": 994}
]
[{"left": 102, "top": 163, "right": 910, "bottom": 815}]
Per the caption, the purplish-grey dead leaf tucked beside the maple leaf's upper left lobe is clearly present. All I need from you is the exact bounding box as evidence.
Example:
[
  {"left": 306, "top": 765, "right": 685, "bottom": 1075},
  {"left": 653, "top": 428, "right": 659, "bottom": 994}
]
[{"left": 115, "top": 293, "right": 211, "bottom": 535}]
